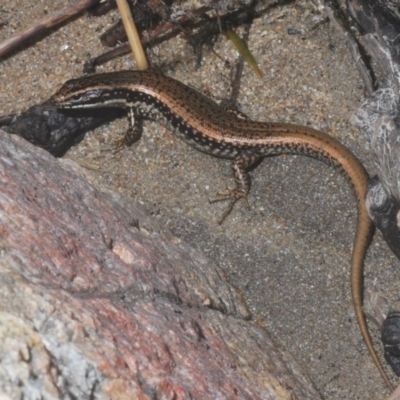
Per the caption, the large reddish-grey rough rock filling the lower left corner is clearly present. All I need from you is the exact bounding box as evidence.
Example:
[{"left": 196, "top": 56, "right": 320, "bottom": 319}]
[{"left": 0, "top": 132, "right": 319, "bottom": 399}]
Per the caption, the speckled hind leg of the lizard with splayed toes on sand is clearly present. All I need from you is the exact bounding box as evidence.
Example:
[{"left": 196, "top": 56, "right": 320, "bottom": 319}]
[{"left": 209, "top": 150, "right": 262, "bottom": 224}]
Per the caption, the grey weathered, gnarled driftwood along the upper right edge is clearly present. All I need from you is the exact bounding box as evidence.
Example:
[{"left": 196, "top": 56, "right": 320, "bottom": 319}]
[{"left": 349, "top": 0, "right": 400, "bottom": 258}]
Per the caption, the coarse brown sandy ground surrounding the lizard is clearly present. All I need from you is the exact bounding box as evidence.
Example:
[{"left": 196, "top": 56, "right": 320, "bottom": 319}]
[{"left": 0, "top": 0, "right": 400, "bottom": 399}]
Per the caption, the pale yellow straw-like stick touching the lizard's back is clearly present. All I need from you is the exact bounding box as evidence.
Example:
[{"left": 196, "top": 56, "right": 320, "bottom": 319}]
[{"left": 117, "top": 0, "right": 149, "bottom": 70}]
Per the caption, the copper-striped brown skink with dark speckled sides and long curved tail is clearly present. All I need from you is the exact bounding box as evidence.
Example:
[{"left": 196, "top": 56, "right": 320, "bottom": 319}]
[{"left": 52, "top": 71, "right": 393, "bottom": 390}]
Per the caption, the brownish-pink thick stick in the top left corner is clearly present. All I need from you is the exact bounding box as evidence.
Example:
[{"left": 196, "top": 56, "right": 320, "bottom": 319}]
[{"left": 0, "top": 0, "right": 100, "bottom": 58}]
